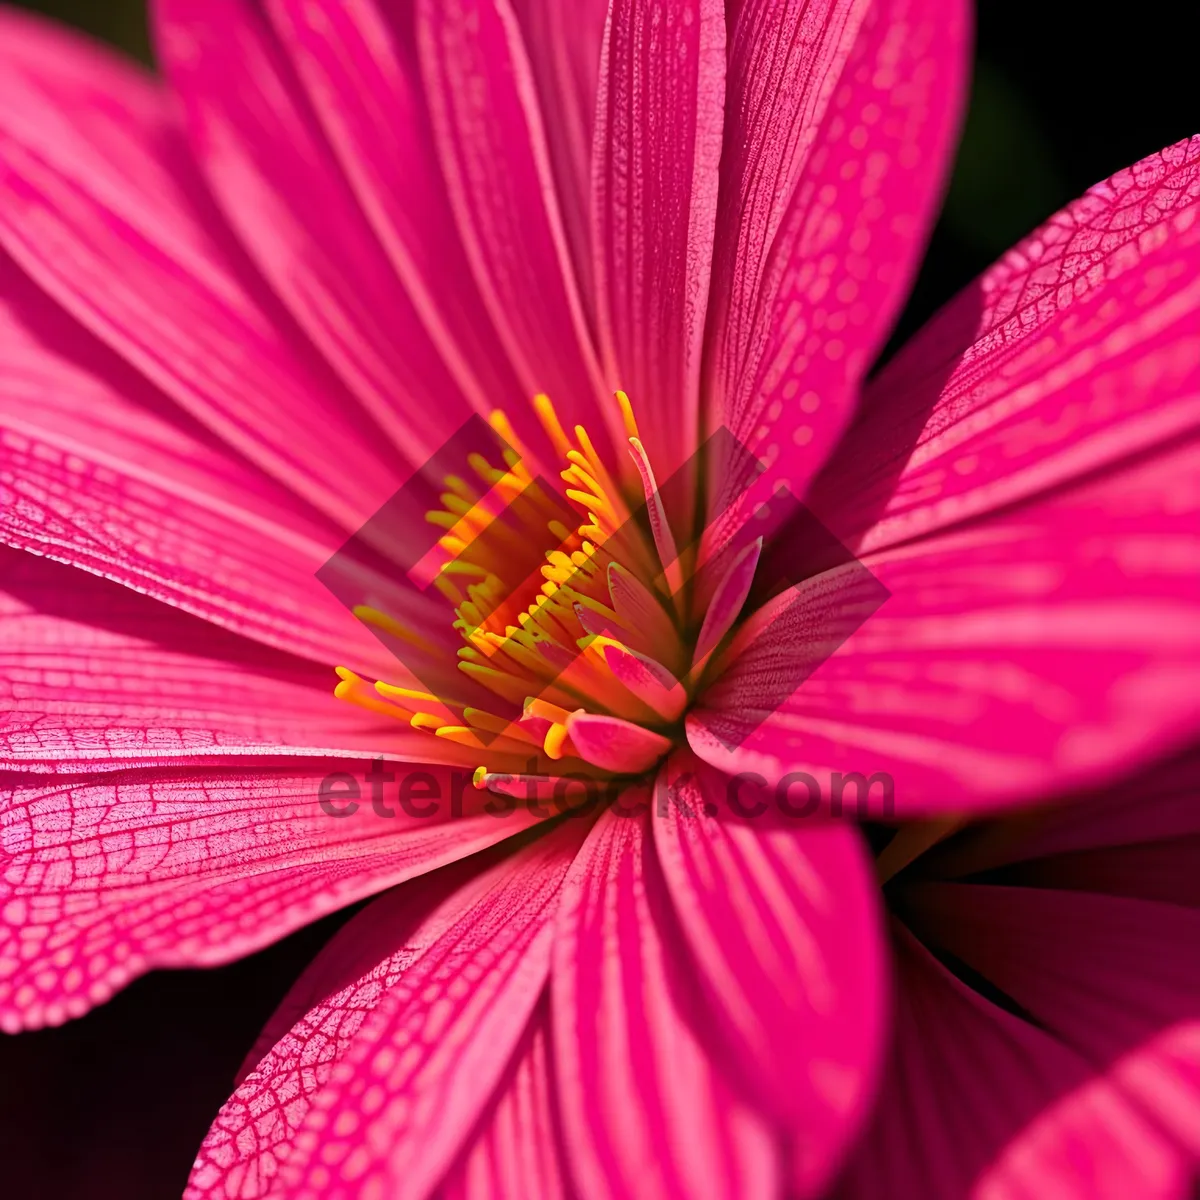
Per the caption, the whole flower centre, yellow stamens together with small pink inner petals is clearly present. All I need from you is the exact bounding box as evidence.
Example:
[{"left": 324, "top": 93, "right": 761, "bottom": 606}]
[{"left": 336, "top": 391, "right": 761, "bottom": 791}]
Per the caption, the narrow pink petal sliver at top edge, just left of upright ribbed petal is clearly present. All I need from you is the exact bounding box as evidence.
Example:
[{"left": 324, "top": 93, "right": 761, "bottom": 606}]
[{"left": 512, "top": 0, "right": 608, "bottom": 319}]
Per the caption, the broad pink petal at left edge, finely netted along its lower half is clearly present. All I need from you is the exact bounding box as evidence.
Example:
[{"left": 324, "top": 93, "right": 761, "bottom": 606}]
[{"left": 0, "top": 263, "right": 394, "bottom": 670}]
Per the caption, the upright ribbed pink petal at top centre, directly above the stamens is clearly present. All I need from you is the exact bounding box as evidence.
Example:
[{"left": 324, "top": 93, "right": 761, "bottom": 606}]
[{"left": 592, "top": 0, "right": 725, "bottom": 478}]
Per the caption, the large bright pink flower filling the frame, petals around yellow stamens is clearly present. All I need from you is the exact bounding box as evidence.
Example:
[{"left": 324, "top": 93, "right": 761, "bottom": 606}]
[{"left": 0, "top": 0, "right": 1200, "bottom": 1200}]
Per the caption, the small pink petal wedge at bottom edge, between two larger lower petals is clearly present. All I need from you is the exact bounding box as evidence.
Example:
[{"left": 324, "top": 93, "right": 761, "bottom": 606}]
[{"left": 438, "top": 995, "right": 569, "bottom": 1200}]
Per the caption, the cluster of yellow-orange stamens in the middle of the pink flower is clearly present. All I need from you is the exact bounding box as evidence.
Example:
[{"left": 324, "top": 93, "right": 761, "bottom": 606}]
[{"left": 337, "top": 391, "right": 690, "bottom": 787}]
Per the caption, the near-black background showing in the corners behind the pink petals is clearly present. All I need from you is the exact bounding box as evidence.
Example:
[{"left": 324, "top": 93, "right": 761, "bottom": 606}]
[{"left": 0, "top": 0, "right": 1200, "bottom": 1200}]
